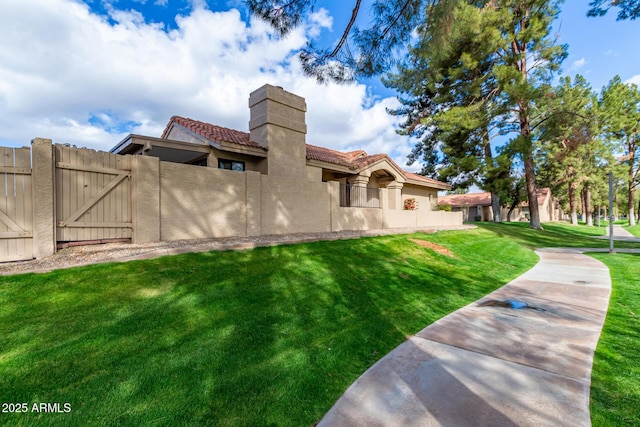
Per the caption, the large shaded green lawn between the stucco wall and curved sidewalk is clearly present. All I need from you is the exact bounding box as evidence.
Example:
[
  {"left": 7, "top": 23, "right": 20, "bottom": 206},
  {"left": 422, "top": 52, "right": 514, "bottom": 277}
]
[{"left": 0, "top": 223, "right": 640, "bottom": 426}]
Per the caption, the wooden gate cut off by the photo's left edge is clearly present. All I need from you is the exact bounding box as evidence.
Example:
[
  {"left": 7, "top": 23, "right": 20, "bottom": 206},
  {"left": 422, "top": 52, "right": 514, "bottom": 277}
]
[{"left": 0, "top": 147, "right": 33, "bottom": 262}]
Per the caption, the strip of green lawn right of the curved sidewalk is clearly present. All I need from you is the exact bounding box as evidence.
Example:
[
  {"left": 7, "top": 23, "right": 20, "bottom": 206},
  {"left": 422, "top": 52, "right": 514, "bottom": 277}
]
[{"left": 591, "top": 253, "right": 640, "bottom": 426}]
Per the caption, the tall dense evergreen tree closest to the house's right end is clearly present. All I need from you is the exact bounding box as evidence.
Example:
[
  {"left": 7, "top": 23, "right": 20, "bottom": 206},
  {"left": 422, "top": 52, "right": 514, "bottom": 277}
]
[{"left": 384, "top": 3, "right": 509, "bottom": 222}]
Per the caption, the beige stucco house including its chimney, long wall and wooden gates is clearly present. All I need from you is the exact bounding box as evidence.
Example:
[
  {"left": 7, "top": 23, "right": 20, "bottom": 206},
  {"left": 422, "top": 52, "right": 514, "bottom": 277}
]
[{"left": 6, "top": 85, "right": 462, "bottom": 261}]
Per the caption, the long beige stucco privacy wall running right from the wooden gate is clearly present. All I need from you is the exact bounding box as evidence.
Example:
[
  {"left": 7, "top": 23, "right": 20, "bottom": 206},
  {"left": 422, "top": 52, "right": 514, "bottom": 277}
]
[{"left": 140, "top": 161, "right": 462, "bottom": 242}]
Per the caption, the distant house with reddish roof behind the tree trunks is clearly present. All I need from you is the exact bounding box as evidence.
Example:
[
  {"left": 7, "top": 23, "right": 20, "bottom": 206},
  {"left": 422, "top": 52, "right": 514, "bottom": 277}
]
[{"left": 438, "top": 188, "right": 562, "bottom": 222}]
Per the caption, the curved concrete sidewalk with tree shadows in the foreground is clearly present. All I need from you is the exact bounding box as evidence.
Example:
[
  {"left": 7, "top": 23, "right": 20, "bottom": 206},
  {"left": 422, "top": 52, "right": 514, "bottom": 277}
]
[{"left": 318, "top": 249, "right": 611, "bottom": 427}]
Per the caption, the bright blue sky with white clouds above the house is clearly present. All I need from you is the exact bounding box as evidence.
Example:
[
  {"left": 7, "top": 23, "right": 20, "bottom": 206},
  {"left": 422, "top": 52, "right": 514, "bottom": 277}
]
[{"left": 0, "top": 0, "right": 640, "bottom": 170}]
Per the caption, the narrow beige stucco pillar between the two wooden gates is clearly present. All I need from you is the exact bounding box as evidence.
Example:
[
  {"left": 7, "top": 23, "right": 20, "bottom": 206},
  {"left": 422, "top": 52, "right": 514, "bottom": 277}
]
[{"left": 31, "top": 138, "right": 56, "bottom": 258}]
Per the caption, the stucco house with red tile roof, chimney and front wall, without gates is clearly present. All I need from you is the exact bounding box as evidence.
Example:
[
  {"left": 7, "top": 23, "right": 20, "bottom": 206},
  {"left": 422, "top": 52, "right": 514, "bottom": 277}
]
[{"left": 111, "top": 85, "right": 462, "bottom": 240}]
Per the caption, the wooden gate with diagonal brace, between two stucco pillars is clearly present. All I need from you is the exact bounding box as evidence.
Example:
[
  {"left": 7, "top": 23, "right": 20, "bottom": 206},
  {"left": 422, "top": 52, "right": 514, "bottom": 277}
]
[{"left": 55, "top": 144, "right": 132, "bottom": 242}]
